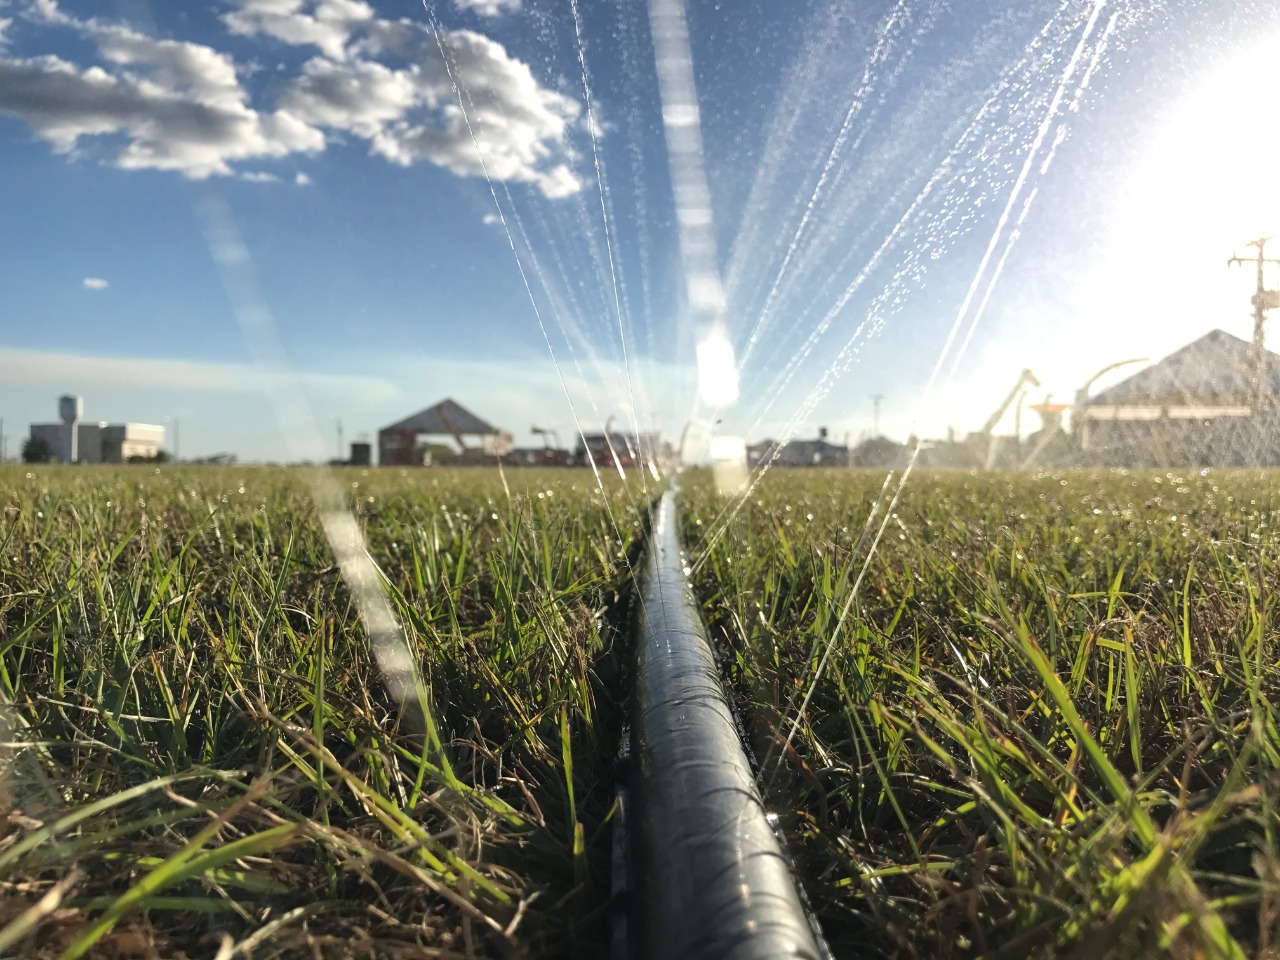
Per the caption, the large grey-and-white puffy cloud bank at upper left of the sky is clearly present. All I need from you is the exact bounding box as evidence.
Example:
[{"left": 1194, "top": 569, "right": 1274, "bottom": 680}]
[{"left": 0, "top": 0, "right": 582, "bottom": 197}]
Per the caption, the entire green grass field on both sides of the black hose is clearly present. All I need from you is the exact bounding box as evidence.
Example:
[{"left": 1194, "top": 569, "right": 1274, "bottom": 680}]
[{"left": 0, "top": 467, "right": 1280, "bottom": 960}]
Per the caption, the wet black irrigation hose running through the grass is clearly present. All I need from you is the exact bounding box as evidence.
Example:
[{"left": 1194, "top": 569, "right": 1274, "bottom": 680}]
[{"left": 626, "top": 493, "right": 824, "bottom": 960}]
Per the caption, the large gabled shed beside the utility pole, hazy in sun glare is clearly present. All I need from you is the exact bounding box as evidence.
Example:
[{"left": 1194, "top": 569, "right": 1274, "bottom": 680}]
[{"left": 1073, "top": 330, "right": 1280, "bottom": 467}]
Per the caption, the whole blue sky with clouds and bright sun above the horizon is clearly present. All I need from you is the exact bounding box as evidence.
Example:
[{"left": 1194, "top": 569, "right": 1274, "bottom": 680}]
[{"left": 0, "top": 0, "right": 1280, "bottom": 461}]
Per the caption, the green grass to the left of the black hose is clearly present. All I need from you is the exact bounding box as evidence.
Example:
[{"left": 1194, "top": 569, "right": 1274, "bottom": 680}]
[{"left": 0, "top": 467, "right": 644, "bottom": 957}]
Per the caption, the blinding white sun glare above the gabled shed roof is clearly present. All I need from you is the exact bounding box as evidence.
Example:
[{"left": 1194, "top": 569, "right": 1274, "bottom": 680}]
[{"left": 1092, "top": 35, "right": 1280, "bottom": 360}]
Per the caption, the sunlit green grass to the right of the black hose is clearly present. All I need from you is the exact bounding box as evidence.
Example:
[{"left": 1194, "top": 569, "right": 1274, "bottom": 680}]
[{"left": 684, "top": 471, "right": 1280, "bottom": 960}]
